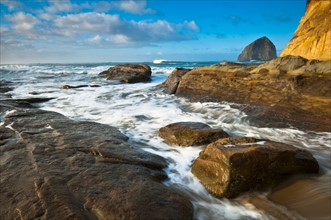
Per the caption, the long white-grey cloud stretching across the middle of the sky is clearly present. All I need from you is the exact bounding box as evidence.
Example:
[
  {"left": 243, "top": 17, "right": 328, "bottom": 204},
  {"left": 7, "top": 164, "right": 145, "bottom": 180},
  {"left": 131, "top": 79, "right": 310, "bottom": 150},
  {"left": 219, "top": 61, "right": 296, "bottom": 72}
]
[{"left": 53, "top": 12, "right": 198, "bottom": 44}]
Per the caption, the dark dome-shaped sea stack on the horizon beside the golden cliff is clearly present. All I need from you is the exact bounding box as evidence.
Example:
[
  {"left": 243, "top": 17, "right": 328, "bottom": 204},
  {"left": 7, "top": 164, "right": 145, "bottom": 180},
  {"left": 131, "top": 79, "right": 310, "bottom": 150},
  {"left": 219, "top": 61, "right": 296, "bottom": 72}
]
[{"left": 238, "top": 37, "right": 277, "bottom": 62}]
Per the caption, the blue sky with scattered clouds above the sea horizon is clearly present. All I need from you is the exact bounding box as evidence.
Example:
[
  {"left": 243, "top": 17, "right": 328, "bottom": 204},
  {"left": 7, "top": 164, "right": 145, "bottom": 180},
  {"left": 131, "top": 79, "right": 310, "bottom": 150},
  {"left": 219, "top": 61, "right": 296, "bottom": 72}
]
[{"left": 0, "top": 0, "right": 306, "bottom": 64}]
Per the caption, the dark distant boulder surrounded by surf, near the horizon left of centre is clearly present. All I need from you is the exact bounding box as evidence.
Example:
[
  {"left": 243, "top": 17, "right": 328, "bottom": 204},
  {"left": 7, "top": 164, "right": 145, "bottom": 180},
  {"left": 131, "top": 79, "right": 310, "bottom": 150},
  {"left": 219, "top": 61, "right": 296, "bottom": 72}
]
[{"left": 100, "top": 64, "right": 152, "bottom": 83}]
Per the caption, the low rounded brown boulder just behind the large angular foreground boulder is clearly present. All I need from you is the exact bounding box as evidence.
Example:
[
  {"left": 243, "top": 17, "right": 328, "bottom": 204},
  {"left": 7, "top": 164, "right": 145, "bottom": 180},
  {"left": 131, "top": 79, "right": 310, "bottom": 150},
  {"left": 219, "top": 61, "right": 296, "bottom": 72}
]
[{"left": 159, "top": 122, "right": 229, "bottom": 146}]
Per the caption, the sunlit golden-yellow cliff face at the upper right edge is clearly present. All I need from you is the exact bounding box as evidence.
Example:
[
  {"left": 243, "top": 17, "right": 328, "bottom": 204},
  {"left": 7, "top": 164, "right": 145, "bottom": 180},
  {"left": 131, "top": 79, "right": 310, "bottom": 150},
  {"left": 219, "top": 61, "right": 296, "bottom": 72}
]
[{"left": 280, "top": 0, "right": 331, "bottom": 60}]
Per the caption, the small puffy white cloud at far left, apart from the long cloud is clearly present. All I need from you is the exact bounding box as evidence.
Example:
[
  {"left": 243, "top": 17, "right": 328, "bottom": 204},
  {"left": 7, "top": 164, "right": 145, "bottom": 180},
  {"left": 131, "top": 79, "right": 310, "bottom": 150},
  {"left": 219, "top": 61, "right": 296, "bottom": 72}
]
[{"left": 6, "top": 12, "right": 40, "bottom": 32}]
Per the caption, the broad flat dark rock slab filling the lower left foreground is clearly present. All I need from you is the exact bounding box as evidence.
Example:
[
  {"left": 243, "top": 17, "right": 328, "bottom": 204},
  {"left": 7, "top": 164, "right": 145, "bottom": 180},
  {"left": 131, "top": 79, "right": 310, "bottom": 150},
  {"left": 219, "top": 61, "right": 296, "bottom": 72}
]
[{"left": 0, "top": 102, "right": 193, "bottom": 219}]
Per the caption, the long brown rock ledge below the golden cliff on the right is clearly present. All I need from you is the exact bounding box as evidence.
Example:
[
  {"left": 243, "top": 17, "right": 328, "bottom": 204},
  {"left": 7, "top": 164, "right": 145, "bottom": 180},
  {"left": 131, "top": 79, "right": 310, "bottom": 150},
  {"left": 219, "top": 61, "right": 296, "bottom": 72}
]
[{"left": 176, "top": 56, "right": 331, "bottom": 131}]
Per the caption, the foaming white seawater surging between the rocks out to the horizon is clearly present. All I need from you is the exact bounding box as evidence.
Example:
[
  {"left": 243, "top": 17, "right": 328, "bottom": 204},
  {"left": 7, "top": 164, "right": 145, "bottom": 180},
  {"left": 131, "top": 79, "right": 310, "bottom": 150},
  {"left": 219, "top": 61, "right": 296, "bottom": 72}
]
[{"left": 0, "top": 60, "right": 331, "bottom": 219}]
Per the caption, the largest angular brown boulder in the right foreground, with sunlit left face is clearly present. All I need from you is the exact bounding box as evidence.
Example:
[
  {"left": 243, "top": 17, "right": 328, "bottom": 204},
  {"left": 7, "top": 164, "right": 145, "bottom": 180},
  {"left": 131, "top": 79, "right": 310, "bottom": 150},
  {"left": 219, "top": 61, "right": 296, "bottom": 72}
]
[{"left": 192, "top": 141, "right": 319, "bottom": 198}]
